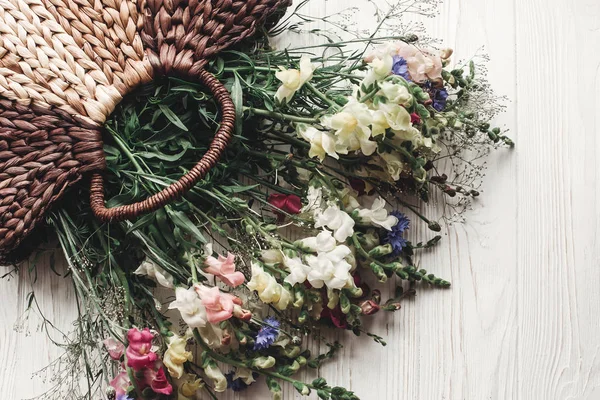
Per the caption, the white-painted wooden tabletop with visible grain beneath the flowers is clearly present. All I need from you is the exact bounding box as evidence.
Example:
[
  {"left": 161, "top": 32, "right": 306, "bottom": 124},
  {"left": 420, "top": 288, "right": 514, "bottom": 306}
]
[{"left": 0, "top": 0, "right": 600, "bottom": 400}]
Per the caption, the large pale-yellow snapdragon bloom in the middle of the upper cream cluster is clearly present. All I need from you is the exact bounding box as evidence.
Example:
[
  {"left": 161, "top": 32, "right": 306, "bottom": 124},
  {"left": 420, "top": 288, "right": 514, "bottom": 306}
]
[{"left": 321, "top": 97, "right": 377, "bottom": 156}]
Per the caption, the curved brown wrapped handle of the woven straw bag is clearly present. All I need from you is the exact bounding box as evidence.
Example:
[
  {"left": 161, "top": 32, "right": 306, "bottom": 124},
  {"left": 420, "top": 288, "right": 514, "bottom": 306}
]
[{"left": 90, "top": 70, "right": 235, "bottom": 222}]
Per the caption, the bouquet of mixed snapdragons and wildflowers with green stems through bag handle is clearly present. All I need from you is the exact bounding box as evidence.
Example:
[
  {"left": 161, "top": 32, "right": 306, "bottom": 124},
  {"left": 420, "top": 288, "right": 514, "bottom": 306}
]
[{"left": 22, "top": 1, "right": 512, "bottom": 400}]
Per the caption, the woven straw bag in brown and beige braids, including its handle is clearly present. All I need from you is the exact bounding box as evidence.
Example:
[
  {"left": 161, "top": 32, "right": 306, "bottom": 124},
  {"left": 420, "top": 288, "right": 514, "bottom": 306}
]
[{"left": 0, "top": 0, "right": 291, "bottom": 259}]
